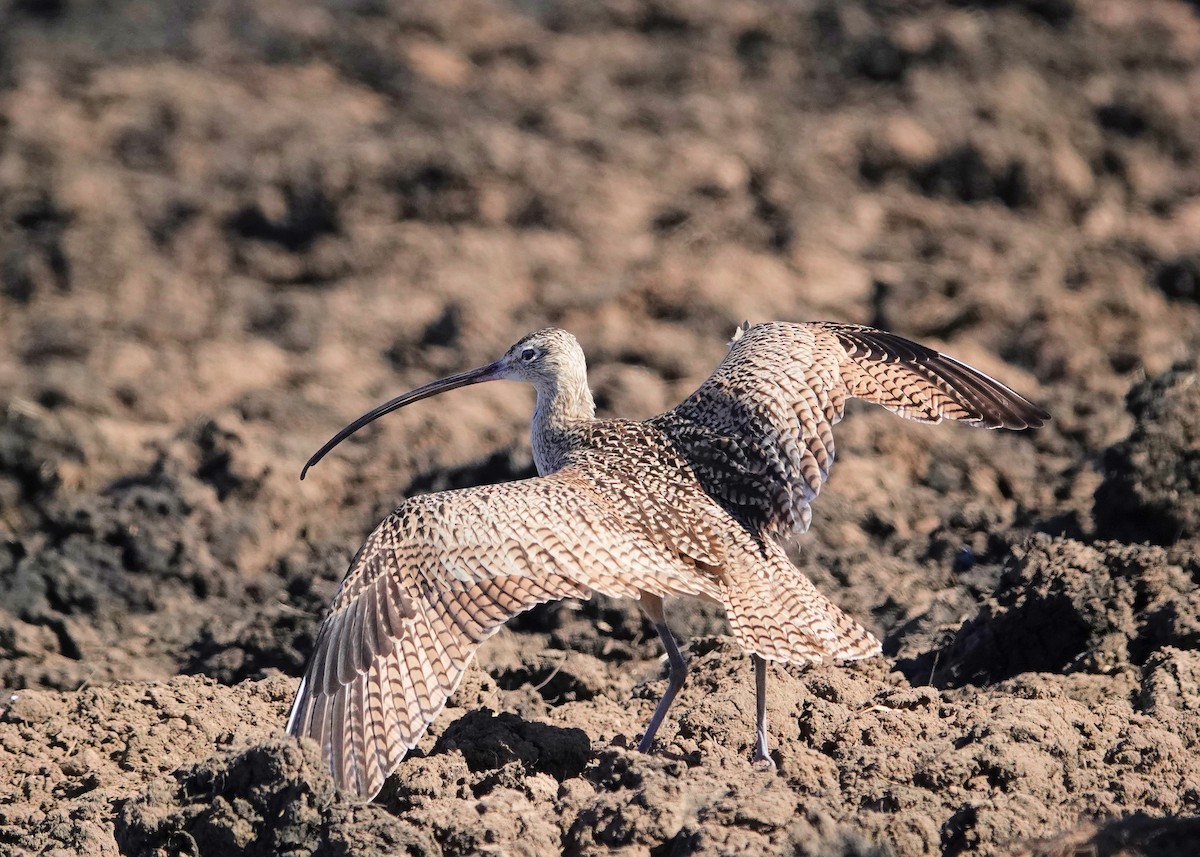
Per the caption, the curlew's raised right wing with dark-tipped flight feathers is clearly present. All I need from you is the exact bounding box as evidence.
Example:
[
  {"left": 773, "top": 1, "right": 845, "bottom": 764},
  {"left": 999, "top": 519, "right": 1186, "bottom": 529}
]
[{"left": 652, "top": 322, "right": 1049, "bottom": 535}]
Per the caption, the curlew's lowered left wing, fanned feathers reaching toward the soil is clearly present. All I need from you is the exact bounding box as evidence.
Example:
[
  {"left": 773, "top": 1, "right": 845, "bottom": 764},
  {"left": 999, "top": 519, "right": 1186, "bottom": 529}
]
[{"left": 288, "top": 467, "right": 697, "bottom": 798}]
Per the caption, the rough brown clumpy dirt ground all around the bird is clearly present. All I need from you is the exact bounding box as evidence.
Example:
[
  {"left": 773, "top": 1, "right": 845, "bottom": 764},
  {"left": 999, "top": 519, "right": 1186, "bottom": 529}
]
[{"left": 0, "top": 0, "right": 1200, "bottom": 857}]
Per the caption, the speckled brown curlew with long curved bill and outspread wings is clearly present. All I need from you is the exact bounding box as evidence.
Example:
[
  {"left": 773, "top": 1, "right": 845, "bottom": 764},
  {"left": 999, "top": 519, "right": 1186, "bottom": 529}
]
[{"left": 287, "top": 322, "right": 1050, "bottom": 801}]
